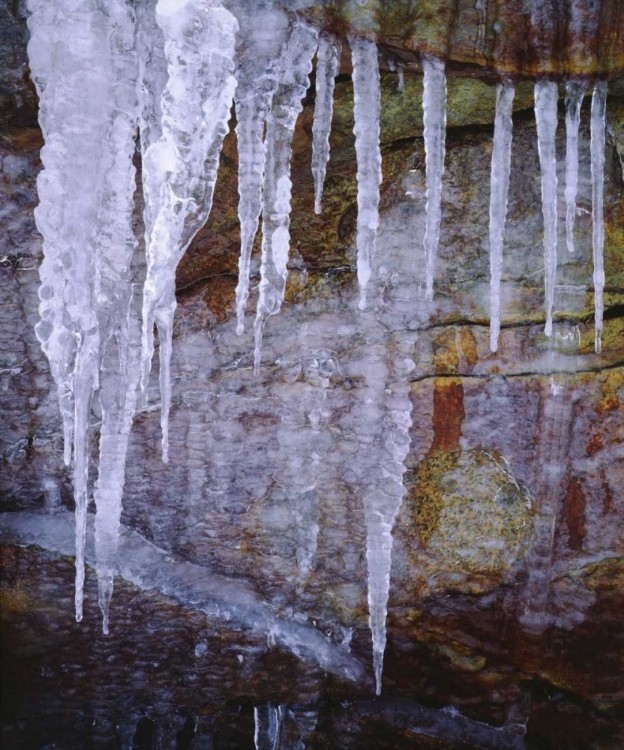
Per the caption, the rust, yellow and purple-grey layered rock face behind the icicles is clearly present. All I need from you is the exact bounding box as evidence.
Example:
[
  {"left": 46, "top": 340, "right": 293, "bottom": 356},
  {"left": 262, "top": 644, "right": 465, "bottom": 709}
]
[{"left": 0, "top": 1, "right": 624, "bottom": 750}]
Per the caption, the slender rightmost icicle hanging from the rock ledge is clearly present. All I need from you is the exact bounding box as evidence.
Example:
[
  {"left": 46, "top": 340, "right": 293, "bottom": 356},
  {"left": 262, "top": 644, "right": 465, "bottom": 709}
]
[{"left": 591, "top": 81, "right": 607, "bottom": 354}]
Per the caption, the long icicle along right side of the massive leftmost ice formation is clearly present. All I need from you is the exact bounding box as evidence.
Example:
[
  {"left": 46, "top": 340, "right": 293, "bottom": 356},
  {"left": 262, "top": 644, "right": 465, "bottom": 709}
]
[{"left": 94, "top": 0, "right": 140, "bottom": 633}]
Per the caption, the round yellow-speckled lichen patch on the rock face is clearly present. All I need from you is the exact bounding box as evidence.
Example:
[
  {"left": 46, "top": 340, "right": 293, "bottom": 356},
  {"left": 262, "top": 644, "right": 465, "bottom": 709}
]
[{"left": 410, "top": 450, "right": 531, "bottom": 592}]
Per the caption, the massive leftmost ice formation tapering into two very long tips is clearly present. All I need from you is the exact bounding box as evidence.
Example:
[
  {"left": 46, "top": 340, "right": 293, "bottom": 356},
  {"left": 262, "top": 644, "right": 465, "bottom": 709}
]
[{"left": 29, "top": 0, "right": 137, "bottom": 628}]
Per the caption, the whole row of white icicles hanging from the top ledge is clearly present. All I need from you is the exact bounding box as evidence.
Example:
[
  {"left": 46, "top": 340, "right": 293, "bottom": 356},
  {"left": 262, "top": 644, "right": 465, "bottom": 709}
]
[{"left": 29, "top": 0, "right": 606, "bottom": 691}]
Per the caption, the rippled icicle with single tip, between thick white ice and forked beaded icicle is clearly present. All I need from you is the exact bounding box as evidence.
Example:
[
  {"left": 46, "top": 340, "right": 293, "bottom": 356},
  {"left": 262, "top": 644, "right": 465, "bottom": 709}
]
[{"left": 234, "top": 8, "right": 289, "bottom": 336}]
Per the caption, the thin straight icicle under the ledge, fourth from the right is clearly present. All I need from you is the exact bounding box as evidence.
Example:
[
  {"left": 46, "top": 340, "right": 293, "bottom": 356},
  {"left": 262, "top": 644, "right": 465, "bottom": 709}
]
[{"left": 490, "top": 83, "right": 515, "bottom": 352}]
